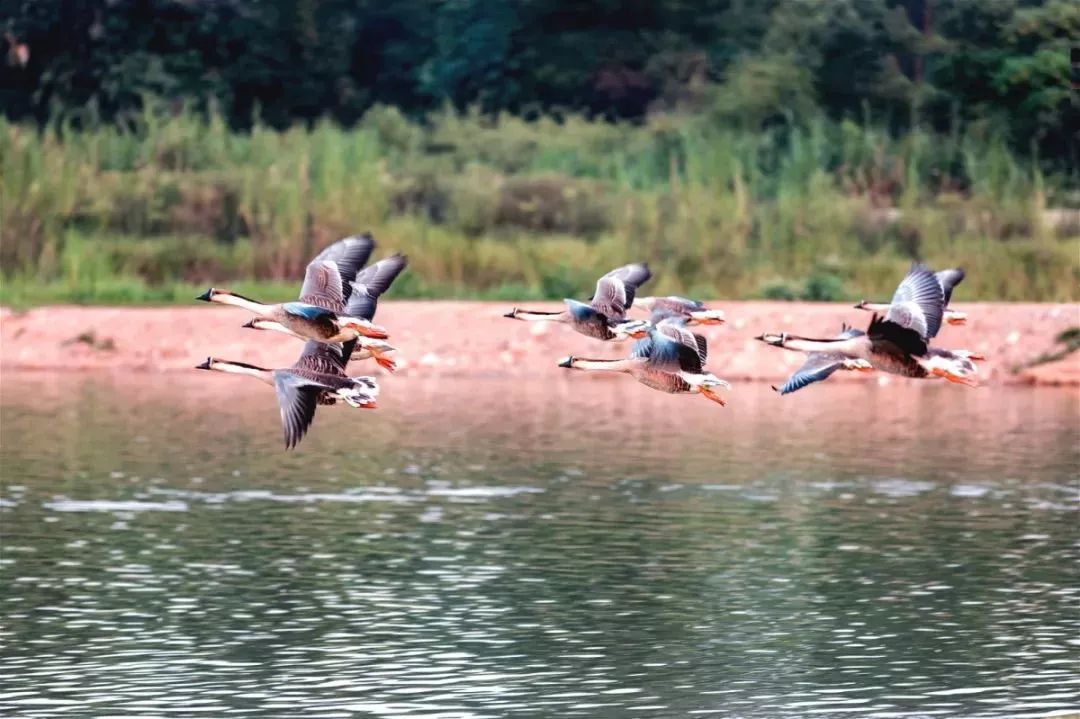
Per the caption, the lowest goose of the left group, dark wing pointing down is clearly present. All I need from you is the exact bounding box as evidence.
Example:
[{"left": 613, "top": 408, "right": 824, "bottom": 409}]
[{"left": 197, "top": 340, "right": 379, "bottom": 449}]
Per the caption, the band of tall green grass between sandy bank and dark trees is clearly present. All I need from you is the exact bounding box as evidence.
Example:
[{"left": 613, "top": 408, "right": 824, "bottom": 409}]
[{"left": 0, "top": 104, "right": 1080, "bottom": 303}]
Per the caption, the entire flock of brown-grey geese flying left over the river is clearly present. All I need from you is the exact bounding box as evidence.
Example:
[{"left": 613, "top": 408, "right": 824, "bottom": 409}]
[{"left": 197, "top": 234, "right": 983, "bottom": 448}]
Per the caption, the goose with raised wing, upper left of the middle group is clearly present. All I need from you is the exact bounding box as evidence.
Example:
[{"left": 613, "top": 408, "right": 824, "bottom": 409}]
[{"left": 503, "top": 263, "right": 652, "bottom": 340}]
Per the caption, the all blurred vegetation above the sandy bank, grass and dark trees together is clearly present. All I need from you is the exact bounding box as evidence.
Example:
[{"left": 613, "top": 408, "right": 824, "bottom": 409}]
[{"left": 0, "top": 0, "right": 1080, "bottom": 304}]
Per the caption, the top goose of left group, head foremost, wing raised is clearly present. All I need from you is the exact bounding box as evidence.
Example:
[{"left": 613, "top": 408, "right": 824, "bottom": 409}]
[{"left": 195, "top": 235, "right": 387, "bottom": 343}]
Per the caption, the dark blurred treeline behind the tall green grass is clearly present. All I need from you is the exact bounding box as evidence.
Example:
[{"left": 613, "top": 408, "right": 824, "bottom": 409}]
[{"left": 0, "top": 0, "right": 1080, "bottom": 172}]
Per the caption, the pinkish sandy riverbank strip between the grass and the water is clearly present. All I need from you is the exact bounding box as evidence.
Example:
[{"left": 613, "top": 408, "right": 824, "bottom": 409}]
[{"left": 0, "top": 301, "right": 1080, "bottom": 385}]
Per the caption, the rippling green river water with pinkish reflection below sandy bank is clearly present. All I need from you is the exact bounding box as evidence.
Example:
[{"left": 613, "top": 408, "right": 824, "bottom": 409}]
[{"left": 0, "top": 374, "right": 1080, "bottom": 718}]
